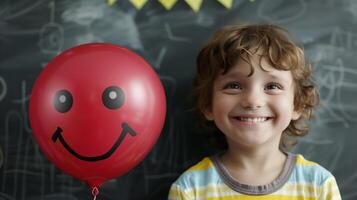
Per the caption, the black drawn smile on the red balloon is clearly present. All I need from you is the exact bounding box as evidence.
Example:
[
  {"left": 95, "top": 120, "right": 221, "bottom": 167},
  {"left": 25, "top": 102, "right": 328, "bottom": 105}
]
[{"left": 52, "top": 123, "right": 136, "bottom": 162}]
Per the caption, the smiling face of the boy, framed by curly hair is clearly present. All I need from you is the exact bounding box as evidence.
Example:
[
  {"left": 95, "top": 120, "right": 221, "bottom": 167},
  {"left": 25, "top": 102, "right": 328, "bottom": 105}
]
[{"left": 205, "top": 54, "right": 300, "bottom": 147}]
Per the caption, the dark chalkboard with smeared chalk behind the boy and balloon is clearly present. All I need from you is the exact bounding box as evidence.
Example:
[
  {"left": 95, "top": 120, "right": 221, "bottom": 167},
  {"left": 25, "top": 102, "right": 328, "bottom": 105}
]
[{"left": 0, "top": 0, "right": 357, "bottom": 200}]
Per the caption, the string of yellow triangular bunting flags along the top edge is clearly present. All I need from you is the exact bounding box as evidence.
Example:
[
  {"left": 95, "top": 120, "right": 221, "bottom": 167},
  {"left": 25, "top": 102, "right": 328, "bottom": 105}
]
[{"left": 106, "top": 0, "right": 238, "bottom": 12}]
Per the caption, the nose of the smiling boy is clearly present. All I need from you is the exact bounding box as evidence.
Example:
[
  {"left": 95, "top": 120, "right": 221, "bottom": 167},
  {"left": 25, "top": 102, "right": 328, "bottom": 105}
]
[{"left": 241, "top": 89, "right": 264, "bottom": 110}]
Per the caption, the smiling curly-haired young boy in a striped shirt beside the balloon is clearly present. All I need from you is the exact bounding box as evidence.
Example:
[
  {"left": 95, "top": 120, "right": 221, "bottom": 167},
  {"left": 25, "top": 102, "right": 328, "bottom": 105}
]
[{"left": 169, "top": 25, "right": 341, "bottom": 200}]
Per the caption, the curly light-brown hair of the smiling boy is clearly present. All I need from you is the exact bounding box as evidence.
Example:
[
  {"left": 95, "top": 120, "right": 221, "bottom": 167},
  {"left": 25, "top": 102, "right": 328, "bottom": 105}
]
[{"left": 193, "top": 24, "right": 319, "bottom": 150}]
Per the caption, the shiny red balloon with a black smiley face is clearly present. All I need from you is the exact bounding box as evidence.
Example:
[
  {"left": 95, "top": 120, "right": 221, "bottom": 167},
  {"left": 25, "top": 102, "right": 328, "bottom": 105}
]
[{"left": 29, "top": 43, "right": 166, "bottom": 191}]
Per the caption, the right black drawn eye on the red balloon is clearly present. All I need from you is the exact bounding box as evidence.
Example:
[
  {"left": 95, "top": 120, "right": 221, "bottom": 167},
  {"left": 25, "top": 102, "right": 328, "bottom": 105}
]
[{"left": 102, "top": 86, "right": 124, "bottom": 110}]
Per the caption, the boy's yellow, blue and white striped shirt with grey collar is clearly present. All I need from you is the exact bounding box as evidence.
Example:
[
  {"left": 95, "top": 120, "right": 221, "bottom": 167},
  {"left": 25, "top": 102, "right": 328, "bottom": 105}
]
[{"left": 169, "top": 153, "right": 341, "bottom": 200}]
